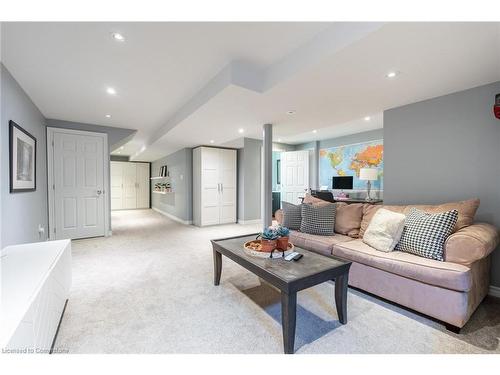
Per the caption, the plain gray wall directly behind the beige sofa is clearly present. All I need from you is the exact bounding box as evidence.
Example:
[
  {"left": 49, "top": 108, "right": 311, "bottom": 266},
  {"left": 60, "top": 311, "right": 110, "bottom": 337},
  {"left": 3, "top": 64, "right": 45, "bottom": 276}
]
[{"left": 384, "top": 82, "right": 500, "bottom": 286}]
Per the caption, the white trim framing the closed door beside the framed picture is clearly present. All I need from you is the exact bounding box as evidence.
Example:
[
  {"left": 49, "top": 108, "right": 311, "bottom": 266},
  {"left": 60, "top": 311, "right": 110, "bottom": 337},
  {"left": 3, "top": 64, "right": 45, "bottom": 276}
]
[{"left": 46, "top": 127, "right": 111, "bottom": 240}]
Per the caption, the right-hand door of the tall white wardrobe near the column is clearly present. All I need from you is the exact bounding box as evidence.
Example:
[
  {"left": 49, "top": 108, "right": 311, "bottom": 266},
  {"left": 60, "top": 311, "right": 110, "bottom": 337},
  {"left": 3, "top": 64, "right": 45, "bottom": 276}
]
[{"left": 219, "top": 149, "right": 236, "bottom": 224}]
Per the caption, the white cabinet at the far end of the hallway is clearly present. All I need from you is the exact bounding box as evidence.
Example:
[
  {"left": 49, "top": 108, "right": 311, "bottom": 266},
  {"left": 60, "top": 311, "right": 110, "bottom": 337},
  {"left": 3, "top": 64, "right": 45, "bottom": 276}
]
[{"left": 111, "top": 161, "right": 149, "bottom": 210}]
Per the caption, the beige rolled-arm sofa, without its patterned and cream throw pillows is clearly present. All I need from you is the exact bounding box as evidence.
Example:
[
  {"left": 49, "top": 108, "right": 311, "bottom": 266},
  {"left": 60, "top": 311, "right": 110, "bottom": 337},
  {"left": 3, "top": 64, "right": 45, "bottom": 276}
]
[{"left": 276, "top": 195, "right": 499, "bottom": 333}]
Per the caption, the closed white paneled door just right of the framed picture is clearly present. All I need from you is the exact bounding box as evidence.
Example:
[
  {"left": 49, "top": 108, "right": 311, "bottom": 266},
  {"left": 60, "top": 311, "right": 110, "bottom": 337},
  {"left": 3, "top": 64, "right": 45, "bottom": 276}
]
[{"left": 49, "top": 130, "right": 107, "bottom": 239}]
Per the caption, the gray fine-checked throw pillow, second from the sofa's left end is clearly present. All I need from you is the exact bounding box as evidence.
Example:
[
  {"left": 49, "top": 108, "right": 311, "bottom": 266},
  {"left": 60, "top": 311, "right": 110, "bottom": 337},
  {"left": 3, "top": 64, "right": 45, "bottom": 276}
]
[{"left": 300, "top": 203, "right": 335, "bottom": 236}]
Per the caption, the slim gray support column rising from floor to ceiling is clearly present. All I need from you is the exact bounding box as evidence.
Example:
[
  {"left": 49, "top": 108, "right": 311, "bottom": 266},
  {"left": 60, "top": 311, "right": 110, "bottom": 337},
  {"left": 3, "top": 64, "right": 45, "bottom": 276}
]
[{"left": 262, "top": 124, "right": 273, "bottom": 229}]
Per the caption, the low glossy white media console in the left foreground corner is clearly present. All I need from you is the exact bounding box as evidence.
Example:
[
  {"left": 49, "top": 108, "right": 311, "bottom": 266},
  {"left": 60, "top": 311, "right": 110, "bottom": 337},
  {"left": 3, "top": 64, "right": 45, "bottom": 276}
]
[{"left": 0, "top": 240, "right": 71, "bottom": 353}]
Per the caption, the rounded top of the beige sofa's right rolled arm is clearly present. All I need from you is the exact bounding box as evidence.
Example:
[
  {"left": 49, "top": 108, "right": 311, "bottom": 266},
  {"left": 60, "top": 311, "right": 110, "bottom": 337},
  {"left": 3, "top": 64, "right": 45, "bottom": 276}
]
[{"left": 443, "top": 223, "right": 499, "bottom": 265}]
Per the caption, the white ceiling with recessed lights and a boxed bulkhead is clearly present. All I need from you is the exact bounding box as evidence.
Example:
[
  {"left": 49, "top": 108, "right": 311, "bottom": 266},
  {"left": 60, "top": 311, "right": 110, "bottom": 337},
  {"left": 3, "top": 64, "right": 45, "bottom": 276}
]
[{"left": 2, "top": 23, "right": 500, "bottom": 160}]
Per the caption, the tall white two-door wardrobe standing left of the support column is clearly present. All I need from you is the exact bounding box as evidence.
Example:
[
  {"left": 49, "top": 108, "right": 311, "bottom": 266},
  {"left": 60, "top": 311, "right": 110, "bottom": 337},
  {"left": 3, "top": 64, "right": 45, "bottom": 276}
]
[{"left": 193, "top": 147, "right": 237, "bottom": 226}]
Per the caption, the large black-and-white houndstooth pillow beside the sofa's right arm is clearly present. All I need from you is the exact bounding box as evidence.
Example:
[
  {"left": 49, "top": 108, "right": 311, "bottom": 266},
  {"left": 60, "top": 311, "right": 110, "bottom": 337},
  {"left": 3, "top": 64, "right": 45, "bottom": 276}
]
[{"left": 395, "top": 208, "right": 458, "bottom": 261}]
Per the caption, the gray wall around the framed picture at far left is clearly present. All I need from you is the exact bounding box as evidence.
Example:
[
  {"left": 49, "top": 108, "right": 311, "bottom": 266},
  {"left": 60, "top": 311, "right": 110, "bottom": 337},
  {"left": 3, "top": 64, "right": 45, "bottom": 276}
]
[{"left": 0, "top": 64, "right": 48, "bottom": 247}]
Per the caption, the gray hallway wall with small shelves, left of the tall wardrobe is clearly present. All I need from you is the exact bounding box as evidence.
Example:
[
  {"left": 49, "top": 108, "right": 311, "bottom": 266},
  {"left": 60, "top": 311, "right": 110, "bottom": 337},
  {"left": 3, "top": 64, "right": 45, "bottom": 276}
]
[{"left": 151, "top": 148, "right": 193, "bottom": 222}]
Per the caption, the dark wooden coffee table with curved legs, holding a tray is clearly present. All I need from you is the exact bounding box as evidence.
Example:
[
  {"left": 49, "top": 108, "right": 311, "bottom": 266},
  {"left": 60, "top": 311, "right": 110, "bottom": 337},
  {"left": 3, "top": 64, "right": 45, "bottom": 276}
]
[{"left": 212, "top": 233, "right": 351, "bottom": 354}]
